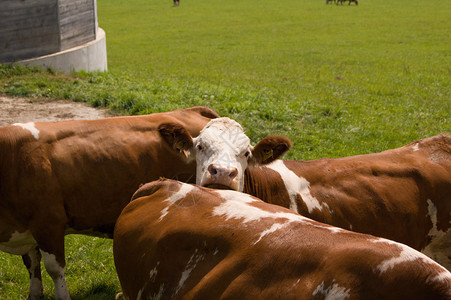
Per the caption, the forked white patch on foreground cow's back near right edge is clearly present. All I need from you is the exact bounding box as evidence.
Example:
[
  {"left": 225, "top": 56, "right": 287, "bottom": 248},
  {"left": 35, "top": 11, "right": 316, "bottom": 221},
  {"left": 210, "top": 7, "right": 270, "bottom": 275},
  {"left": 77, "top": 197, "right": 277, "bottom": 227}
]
[{"left": 370, "top": 238, "right": 446, "bottom": 274}]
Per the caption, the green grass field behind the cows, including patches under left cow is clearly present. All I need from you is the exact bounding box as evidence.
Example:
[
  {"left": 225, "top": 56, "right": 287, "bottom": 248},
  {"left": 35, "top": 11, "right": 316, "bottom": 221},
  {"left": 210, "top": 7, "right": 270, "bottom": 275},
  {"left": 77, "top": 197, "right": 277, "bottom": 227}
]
[{"left": 0, "top": 0, "right": 451, "bottom": 299}]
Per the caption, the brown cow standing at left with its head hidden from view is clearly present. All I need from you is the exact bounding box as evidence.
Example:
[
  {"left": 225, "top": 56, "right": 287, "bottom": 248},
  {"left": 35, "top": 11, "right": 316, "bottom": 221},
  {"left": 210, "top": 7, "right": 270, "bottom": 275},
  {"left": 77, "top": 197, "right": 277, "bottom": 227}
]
[{"left": 0, "top": 107, "right": 218, "bottom": 299}]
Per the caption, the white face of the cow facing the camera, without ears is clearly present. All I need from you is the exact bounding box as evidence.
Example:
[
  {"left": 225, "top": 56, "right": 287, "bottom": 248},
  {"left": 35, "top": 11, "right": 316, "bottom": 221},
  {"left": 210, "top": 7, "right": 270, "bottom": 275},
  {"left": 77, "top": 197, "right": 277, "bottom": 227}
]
[{"left": 193, "top": 118, "right": 252, "bottom": 191}]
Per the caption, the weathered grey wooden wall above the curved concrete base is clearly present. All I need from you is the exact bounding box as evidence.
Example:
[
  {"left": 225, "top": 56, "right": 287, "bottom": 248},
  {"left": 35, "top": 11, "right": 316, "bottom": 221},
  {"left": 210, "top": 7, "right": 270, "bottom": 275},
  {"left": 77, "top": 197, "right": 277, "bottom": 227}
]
[{"left": 0, "top": 0, "right": 98, "bottom": 63}]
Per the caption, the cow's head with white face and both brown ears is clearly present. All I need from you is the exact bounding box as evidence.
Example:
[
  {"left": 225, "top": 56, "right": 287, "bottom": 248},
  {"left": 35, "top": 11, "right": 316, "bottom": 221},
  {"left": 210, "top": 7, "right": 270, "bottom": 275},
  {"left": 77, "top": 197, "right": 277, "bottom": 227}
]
[{"left": 159, "top": 118, "right": 291, "bottom": 191}]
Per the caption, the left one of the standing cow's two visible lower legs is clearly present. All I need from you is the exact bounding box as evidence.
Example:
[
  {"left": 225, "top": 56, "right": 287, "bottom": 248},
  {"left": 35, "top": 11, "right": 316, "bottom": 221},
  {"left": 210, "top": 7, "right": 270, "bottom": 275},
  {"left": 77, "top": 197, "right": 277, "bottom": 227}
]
[{"left": 22, "top": 247, "right": 44, "bottom": 300}]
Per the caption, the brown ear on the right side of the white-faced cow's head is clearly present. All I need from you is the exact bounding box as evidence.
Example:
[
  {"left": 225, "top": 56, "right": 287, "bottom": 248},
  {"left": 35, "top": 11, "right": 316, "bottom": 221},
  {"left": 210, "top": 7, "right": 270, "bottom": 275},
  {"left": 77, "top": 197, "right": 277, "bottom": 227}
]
[{"left": 249, "top": 136, "right": 291, "bottom": 165}]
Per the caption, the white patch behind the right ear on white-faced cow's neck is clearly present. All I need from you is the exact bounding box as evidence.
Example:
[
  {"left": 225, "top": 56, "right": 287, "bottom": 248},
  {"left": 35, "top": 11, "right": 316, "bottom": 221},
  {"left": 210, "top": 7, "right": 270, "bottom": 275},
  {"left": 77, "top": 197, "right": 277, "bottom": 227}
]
[{"left": 267, "top": 160, "right": 332, "bottom": 214}]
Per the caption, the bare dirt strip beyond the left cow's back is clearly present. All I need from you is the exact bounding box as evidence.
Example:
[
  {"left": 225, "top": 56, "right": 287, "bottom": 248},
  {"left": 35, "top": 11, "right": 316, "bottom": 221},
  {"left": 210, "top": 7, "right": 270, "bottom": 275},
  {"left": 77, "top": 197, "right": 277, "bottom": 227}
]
[{"left": 0, "top": 95, "right": 112, "bottom": 126}]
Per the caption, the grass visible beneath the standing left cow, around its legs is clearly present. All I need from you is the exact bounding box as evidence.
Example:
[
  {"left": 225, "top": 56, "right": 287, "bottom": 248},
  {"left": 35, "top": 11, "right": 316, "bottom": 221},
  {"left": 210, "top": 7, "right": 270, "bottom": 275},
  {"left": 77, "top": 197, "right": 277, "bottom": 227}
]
[{"left": 0, "top": 235, "right": 120, "bottom": 300}]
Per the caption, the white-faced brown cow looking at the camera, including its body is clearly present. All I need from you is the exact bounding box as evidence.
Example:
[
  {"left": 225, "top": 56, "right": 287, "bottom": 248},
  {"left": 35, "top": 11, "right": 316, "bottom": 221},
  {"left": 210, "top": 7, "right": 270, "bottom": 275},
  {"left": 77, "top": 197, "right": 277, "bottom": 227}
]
[{"left": 159, "top": 118, "right": 451, "bottom": 270}]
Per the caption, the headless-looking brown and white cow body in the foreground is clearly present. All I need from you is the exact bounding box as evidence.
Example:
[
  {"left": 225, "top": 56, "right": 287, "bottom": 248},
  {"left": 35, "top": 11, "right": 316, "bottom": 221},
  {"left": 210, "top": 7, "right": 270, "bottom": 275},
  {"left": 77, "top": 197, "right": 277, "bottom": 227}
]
[{"left": 113, "top": 180, "right": 451, "bottom": 300}]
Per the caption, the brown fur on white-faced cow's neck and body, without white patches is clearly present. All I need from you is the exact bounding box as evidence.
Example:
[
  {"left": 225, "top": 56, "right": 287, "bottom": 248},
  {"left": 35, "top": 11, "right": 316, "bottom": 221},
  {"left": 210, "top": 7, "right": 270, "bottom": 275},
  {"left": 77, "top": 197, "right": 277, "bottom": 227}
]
[{"left": 245, "top": 135, "right": 451, "bottom": 268}]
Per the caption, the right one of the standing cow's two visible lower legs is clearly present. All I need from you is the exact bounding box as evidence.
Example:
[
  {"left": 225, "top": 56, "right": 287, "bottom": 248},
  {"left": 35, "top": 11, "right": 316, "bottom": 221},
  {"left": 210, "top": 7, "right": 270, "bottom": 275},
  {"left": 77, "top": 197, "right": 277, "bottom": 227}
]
[{"left": 41, "top": 250, "right": 70, "bottom": 300}]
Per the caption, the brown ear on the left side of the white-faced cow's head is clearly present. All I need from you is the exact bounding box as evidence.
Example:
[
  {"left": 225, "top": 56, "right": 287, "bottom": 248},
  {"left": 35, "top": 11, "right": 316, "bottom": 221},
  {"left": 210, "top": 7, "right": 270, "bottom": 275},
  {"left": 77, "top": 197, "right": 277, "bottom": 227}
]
[{"left": 158, "top": 123, "right": 193, "bottom": 159}]
